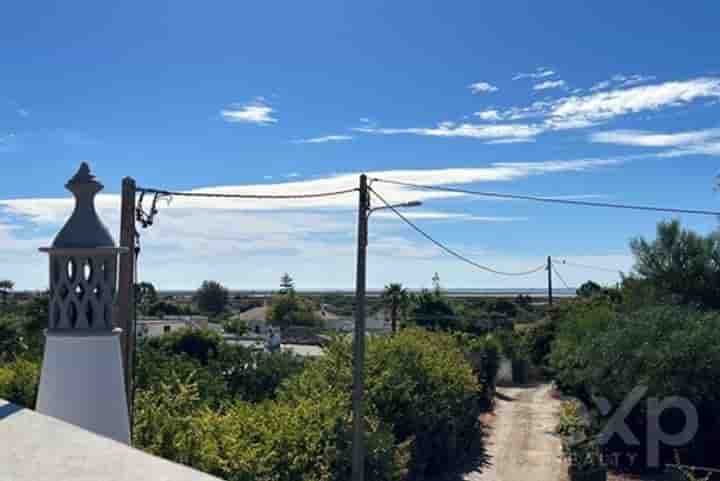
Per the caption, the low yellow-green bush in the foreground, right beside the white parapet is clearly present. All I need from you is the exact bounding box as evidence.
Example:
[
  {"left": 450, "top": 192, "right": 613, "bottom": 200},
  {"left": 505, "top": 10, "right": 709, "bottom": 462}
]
[{"left": 133, "top": 380, "right": 399, "bottom": 481}]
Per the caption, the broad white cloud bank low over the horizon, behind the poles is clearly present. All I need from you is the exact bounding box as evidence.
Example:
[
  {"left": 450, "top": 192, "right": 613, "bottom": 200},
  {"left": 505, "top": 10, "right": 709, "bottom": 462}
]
[{"left": 0, "top": 159, "right": 640, "bottom": 289}]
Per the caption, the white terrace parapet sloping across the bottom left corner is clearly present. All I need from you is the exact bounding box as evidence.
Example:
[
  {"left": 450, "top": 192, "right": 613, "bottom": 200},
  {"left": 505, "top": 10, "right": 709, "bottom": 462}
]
[{"left": 0, "top": 399, "right": 218, "bottom": 481}]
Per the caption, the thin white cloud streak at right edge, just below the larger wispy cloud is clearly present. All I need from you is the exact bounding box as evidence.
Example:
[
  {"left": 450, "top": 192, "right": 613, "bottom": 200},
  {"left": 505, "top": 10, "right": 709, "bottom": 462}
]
[{"left": 590, "top": 129, "right": 720, "bottom": 147}]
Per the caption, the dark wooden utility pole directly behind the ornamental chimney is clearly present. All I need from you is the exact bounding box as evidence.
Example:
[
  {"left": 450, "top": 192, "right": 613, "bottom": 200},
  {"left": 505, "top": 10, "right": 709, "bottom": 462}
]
[{"left": 115, "top": 177, "right": 137, "bottom": 420}]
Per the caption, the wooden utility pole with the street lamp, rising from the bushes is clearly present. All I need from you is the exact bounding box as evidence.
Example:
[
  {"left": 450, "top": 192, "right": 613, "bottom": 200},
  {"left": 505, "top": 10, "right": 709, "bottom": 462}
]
[{"left": 352, "top": 174, "right": 370, "bottom": 481}]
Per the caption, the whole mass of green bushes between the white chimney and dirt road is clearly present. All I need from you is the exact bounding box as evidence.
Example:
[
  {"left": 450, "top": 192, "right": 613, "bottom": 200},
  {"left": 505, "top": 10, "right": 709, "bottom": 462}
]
[{"left": 134, "top": 328, "right": 498, "bottom": 480}]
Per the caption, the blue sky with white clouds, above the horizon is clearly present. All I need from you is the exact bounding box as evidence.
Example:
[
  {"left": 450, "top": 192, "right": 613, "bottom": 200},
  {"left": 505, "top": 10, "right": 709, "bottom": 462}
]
[{"left": 0, "top": 1, "right": 720, "bottom": 288}]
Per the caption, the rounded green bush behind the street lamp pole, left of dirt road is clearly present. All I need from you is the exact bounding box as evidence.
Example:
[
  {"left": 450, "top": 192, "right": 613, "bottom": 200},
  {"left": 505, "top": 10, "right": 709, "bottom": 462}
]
[{"left": 279, "top": 329, "right": 481, "bottom": 479}]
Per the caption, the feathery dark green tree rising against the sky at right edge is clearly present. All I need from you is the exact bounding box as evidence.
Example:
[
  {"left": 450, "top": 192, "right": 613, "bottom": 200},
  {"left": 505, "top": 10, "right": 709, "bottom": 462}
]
[{"left": 630, "top": 220, "right": 720, "bottom": 308}]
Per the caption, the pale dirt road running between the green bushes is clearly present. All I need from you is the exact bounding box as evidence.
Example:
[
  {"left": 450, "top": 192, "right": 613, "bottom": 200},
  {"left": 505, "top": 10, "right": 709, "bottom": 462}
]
[{"left": 464, "top": 384, "right": 562, "bottom": 481}]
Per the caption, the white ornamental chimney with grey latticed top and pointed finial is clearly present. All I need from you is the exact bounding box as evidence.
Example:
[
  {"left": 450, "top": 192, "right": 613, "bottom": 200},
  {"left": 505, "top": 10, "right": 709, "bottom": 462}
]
[{"left": 37, "top": 162, "right": 130, "bottom": 444}]
